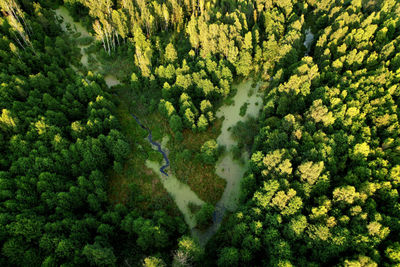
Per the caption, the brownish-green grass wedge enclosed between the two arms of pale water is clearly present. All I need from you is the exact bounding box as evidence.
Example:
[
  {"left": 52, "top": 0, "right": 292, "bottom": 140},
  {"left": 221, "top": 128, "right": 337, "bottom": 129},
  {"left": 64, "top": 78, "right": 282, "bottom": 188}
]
[{"left": 119, "top": 82, "right": 226, "bottom": 204}]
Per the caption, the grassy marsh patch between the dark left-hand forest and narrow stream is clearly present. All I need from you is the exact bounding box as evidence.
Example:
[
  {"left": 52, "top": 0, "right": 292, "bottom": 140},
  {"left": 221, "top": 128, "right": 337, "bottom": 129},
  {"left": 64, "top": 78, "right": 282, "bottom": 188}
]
[{"left": 108, "top": 93, "right": 179, "bottom": 215}]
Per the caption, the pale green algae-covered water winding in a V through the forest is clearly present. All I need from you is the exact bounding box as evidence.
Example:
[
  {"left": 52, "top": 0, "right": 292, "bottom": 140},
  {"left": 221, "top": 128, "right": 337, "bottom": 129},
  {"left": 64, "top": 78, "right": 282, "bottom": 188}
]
[{"left": 55, "top": 7, "right": 262, "bottom": 245}]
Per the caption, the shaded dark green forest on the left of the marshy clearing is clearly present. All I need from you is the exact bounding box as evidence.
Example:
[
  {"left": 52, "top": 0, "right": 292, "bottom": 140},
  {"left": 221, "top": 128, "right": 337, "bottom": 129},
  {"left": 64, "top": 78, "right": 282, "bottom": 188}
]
[{"left": 0, "top": 1, "right": 186, "bottom": 266}]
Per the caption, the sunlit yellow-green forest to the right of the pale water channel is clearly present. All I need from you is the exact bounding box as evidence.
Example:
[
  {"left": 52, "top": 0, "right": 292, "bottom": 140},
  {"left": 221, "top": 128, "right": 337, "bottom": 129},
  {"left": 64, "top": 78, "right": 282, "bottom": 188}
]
[{"left": 207, "top": 1, "right": 400, "bottom": 266}]
